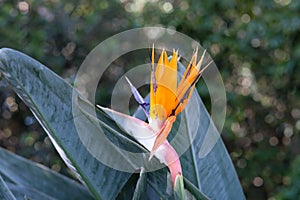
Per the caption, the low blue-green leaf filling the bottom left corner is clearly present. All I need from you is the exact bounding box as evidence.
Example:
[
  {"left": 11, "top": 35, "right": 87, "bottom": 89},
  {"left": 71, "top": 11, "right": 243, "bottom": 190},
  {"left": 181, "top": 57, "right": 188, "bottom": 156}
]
[{"left": 0, "top": 148, "right": 93, "bottom": 200}]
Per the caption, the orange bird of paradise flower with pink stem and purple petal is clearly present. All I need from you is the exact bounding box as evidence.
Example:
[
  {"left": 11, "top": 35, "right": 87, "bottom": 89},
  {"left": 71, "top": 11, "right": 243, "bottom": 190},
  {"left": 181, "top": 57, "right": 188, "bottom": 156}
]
[{"left": 99, "top": 46, "right": 210, "bottom": 199}]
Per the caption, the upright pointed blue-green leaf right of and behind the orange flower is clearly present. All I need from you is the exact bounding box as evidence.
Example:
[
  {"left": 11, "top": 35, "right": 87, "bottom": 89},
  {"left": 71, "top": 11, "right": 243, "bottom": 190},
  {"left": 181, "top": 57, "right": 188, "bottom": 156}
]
[{"left": 175, "top": 84, "right": 245, "bottom": 199}]
